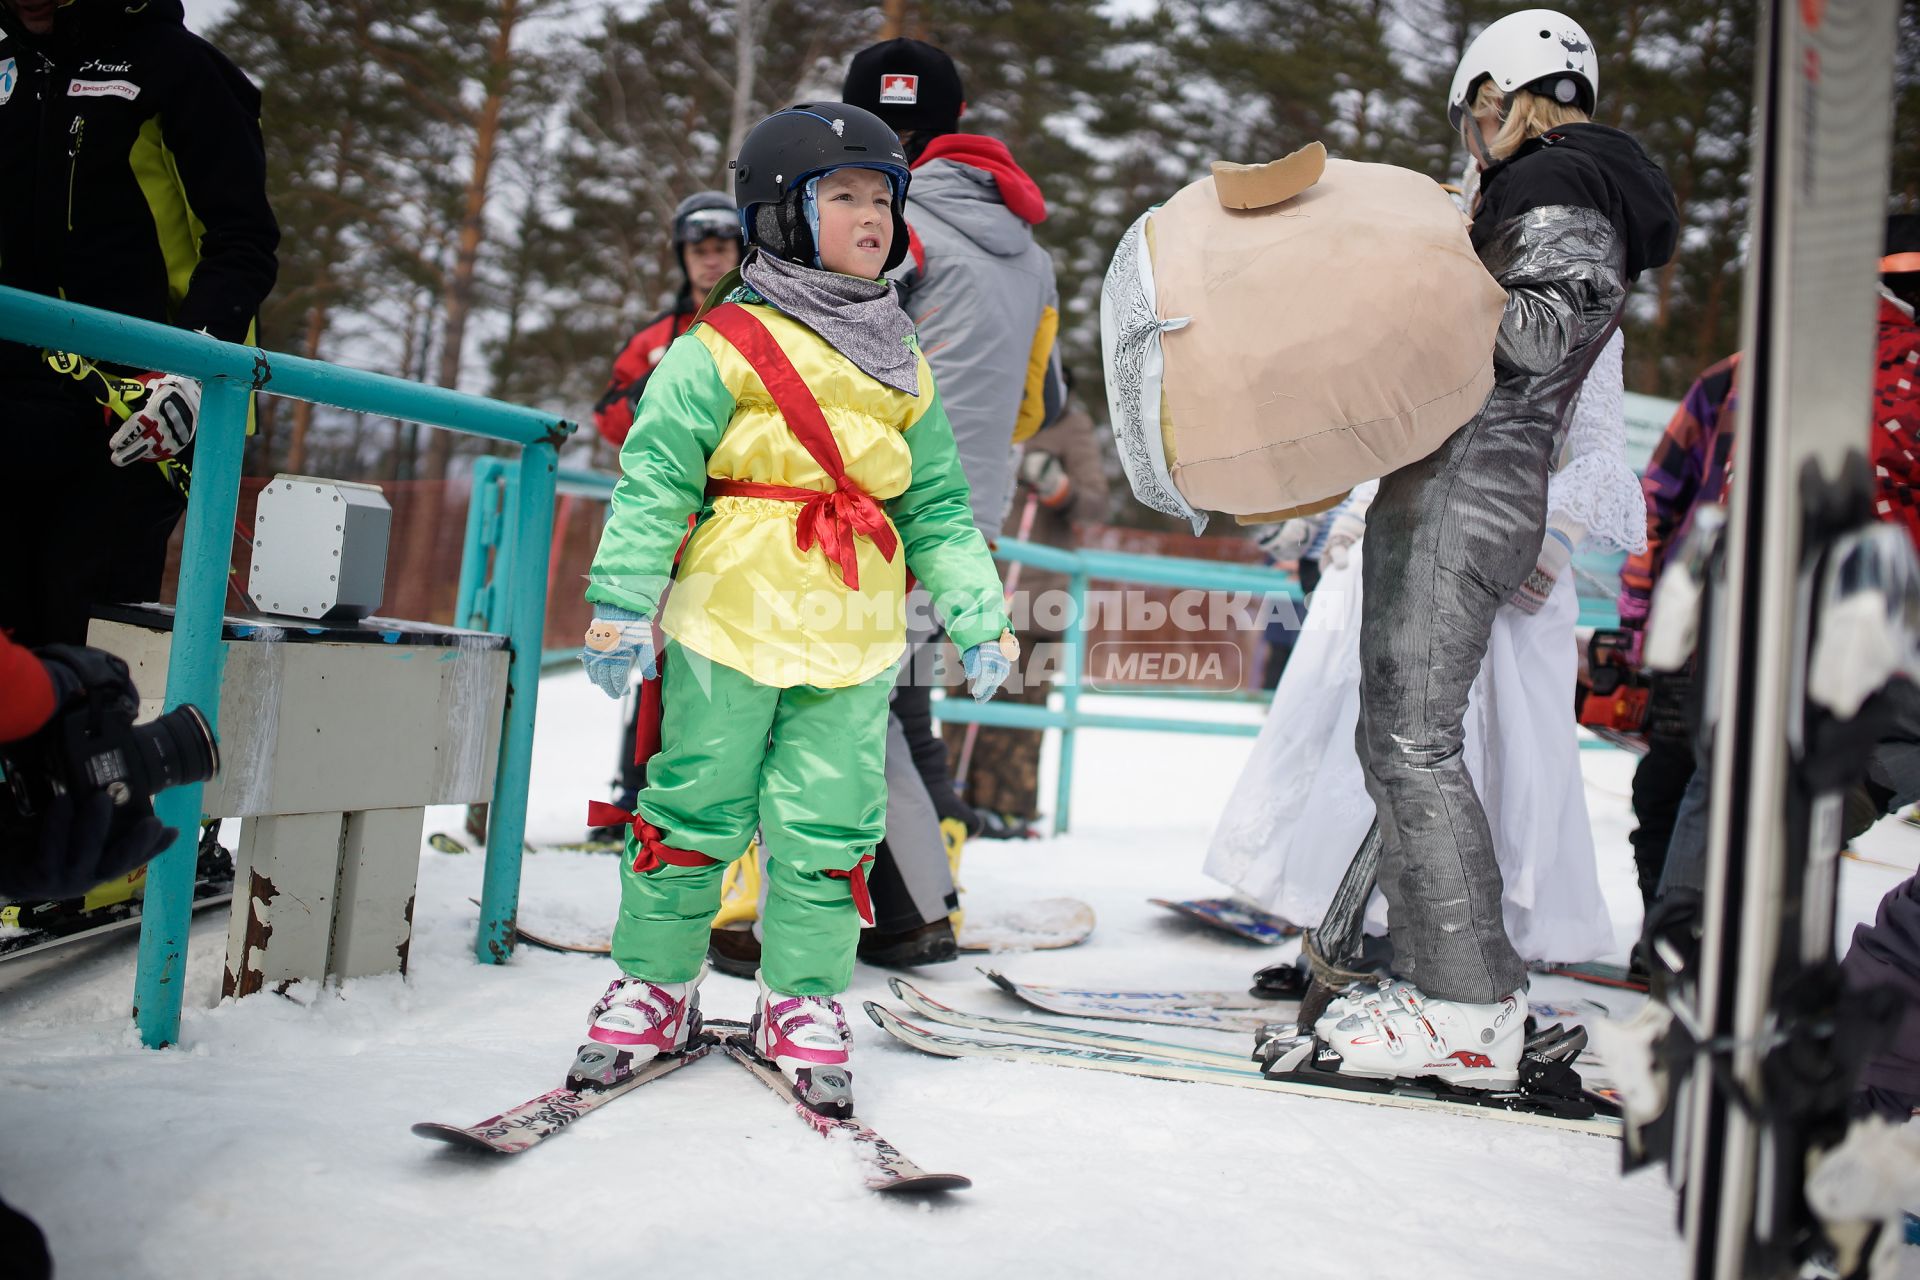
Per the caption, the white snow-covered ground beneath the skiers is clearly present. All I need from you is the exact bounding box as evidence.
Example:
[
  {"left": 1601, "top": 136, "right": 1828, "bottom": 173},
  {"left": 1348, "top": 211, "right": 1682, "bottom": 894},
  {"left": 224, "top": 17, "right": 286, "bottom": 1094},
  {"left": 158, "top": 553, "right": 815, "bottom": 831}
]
[{"left": 0, "top": 676, "right": 1920, "bottom": 1280}]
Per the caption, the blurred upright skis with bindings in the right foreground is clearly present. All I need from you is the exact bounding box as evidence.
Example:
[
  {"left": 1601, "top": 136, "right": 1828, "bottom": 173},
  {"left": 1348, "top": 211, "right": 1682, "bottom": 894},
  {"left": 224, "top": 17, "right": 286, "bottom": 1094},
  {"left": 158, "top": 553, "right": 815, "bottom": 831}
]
[{"left": 1615, "top": 0, "right": 1920, "bottom": 1280}]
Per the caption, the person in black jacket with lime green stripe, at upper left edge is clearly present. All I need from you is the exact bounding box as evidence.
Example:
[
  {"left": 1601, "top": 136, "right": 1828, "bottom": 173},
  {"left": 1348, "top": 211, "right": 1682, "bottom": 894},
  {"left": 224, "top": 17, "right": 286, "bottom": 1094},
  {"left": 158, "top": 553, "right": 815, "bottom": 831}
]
[{"left": 0, "top": 0, "right": 280, "bottom": 645}]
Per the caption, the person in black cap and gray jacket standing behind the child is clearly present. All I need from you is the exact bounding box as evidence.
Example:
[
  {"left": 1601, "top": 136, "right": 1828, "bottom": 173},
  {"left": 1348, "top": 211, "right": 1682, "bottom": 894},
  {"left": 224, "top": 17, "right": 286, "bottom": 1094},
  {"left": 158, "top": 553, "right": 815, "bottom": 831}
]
[{"left": 841, "top": 40, "right": 1066, "bottom": 965}]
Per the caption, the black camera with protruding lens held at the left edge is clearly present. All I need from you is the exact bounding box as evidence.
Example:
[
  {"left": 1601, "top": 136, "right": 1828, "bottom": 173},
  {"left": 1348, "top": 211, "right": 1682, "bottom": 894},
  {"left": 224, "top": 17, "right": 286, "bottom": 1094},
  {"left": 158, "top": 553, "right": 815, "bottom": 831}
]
[{"left": 0, "top": 645, "right": 221, "bottom": 825}]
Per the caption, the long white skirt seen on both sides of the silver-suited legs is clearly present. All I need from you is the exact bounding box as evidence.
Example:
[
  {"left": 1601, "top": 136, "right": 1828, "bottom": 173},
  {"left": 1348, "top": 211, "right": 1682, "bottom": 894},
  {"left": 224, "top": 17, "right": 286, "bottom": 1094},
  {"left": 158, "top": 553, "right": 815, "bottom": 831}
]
[{"left": 1206, "top": 541, "right": 1613, "bottom": 961}]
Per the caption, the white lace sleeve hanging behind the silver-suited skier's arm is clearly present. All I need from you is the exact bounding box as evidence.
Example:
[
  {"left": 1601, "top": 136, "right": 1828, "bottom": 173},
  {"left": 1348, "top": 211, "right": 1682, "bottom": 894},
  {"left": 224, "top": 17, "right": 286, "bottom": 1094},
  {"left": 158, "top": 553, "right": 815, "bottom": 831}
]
[{"left": 1548, "top": 330, "right": 1647, "bottom": 553}]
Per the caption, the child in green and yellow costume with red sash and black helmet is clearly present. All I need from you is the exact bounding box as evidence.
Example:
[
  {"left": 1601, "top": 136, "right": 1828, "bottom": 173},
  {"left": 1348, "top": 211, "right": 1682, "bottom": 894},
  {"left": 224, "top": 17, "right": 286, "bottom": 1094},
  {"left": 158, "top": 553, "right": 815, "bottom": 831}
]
[{"left": 582, "top": 102, "right": 1018, "bottom": 1115}]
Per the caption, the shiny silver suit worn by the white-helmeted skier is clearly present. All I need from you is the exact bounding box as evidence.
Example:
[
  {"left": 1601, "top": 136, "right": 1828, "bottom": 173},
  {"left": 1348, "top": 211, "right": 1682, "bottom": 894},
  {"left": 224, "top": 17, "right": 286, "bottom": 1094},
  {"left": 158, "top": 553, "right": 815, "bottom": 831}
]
[{"left": 1356, "top": 205, "right": 1628, "bottom": 1004}]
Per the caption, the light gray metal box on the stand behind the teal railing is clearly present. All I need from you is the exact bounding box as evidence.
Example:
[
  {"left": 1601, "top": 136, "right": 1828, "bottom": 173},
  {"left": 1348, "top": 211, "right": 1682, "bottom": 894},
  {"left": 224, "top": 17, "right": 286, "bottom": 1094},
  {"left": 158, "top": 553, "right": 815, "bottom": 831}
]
[{"left": 248, "top": 474, "right": 394, "bottom": 622}]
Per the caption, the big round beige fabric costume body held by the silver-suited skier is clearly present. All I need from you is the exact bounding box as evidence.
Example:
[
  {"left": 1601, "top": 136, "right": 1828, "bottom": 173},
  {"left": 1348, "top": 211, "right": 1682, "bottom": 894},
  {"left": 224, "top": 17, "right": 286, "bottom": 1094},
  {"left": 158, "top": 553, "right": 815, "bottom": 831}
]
[{"left": 1146, "top": 159, "right": 1507, "bottom": 516}]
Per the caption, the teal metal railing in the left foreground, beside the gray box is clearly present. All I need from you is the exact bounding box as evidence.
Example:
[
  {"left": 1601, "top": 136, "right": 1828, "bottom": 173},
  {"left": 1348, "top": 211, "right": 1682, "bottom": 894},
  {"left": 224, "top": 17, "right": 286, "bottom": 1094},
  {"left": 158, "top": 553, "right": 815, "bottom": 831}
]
[{"left": 0, "top": 288, "right": 574, "bottom": 1046}]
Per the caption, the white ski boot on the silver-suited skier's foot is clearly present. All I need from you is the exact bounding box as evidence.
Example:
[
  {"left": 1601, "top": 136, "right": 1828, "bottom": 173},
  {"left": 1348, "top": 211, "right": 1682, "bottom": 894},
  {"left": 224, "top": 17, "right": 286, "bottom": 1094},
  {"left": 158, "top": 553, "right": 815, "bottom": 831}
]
[{"left": 1313, "top": 979, "right": 1526, "bottom": 1092}]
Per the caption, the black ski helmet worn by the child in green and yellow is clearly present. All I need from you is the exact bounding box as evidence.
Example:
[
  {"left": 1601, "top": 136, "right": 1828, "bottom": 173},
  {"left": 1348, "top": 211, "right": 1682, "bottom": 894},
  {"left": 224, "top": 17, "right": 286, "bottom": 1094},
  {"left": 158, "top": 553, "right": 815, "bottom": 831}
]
[{"left": 733, "top": 102, "right": 912, "bottom": 271}]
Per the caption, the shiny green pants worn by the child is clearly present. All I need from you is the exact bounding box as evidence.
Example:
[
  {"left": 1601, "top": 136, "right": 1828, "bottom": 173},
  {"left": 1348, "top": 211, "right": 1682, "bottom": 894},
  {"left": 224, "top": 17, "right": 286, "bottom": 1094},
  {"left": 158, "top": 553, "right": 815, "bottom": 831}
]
[{"left": 612, "top": 643, "right": 893, "bottom": 996}]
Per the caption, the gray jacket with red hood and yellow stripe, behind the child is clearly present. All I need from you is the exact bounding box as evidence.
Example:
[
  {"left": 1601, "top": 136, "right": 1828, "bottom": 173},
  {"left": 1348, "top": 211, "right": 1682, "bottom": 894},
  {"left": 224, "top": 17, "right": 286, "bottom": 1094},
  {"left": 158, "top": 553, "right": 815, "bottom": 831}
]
[{"left": 887, "top": 134, "right": 1066, "bottom": 541}]
